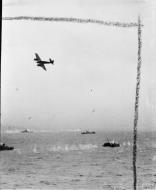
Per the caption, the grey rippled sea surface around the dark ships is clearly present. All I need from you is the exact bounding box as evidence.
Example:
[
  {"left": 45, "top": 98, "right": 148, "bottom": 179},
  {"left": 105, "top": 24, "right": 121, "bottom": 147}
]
[{"left": 0, "top": 131, "right": 156, "bottom": 190}]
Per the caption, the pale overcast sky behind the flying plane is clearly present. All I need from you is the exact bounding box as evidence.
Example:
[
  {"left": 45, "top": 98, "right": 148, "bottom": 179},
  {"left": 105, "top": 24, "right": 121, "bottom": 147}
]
[{"left": 1, "top": 0, "right": 156, "bottom": 131}]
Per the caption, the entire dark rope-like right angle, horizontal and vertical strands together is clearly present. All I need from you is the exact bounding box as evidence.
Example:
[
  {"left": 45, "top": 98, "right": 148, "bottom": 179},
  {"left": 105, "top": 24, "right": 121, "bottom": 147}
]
[{"left": 2, "top": 16, "right": 143, "bottom": 190}]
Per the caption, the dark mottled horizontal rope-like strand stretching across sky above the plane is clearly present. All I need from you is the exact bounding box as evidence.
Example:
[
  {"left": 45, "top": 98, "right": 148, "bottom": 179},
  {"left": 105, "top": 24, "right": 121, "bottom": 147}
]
[{"left": 2, "top": 16, "right": 142, "bottom": 27}]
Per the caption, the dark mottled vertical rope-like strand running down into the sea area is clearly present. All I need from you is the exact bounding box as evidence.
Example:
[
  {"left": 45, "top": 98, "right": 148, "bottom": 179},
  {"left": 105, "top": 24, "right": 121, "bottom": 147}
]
[{"left": 133, "top": 17, "right": 142, "bottom": 190}]
